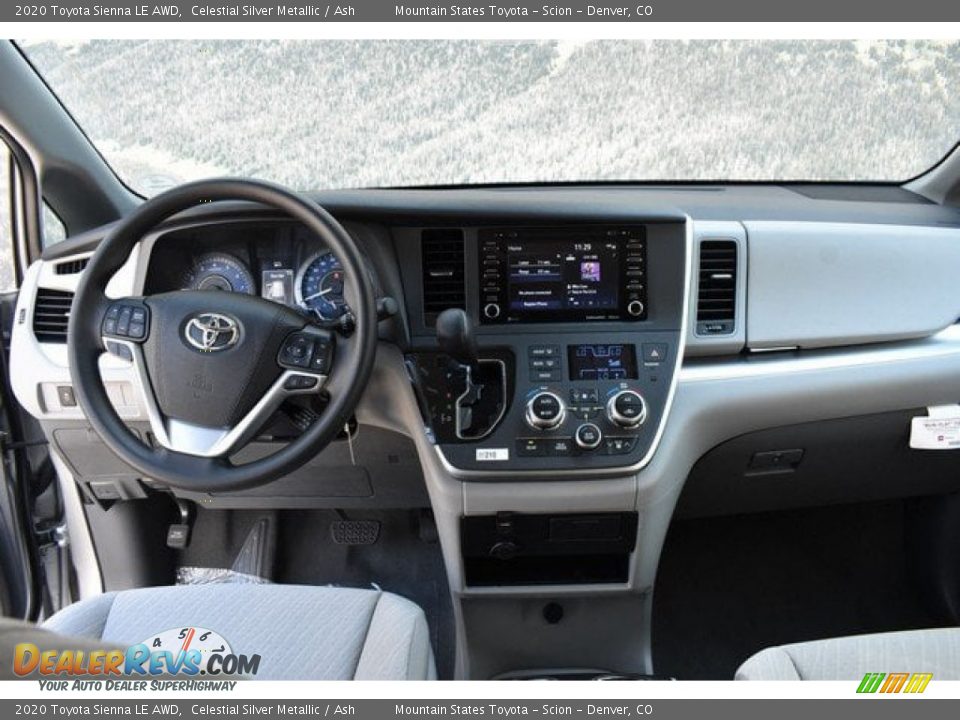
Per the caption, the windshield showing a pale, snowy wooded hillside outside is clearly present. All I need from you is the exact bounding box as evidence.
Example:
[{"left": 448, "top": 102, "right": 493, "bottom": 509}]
[{"left": 24, "top": 40, "right": 960, "bottom": 195}]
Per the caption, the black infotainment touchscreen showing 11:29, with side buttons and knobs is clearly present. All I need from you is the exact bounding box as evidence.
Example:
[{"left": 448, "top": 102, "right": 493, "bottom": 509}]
[{"left": 481, "top": 228, "right": 646, "bottom": 322}]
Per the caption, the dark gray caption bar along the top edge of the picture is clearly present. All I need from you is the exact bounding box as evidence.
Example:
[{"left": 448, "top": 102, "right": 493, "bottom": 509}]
[{"left": 0, "top": 0, "right": 960, "bottom": 23}]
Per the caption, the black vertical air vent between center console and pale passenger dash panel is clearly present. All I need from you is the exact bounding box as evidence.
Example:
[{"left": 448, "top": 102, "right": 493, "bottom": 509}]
[{"left": 697, "top": 240, "right": 737, "bottom": 335}]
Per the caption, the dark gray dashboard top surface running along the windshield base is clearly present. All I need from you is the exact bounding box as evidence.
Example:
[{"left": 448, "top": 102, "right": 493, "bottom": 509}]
[{"left": 43, "top": 184, "right": 960, "bottom": 260}]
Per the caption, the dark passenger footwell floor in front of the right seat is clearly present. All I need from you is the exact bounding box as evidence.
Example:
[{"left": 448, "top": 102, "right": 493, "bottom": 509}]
[{"left": 653, "top": 503, "right": 939, "bottom": 680}]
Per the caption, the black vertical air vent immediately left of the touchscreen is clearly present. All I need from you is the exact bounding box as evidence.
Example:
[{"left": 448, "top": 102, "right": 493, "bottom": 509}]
[{"left": 420, "top": 230, "right": 467, "bottom": 325}]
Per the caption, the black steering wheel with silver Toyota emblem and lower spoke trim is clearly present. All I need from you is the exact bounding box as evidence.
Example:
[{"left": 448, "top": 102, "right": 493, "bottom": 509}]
[{"left": 67, "top": 179, "right": 377, "bottom": 491}]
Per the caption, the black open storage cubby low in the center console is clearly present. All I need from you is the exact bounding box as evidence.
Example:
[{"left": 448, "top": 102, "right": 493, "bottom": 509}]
[{"left": 460, "top": 512, "right": 637, "bottom": 587}]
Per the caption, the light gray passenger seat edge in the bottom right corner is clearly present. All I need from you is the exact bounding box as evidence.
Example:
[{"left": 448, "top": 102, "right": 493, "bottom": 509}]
[{"left": 736, "top": 628, "right": 960, "bottom": 680}]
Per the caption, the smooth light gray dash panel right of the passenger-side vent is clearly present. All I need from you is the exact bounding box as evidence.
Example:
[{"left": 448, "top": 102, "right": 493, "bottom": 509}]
[{"left": 744, "top": 220, "right": 960, "bottom": 349}]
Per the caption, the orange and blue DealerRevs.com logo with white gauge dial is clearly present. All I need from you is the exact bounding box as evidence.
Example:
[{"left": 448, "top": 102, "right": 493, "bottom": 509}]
[{"left": 13, "top": 627, "right": 260, "bottom": 679}]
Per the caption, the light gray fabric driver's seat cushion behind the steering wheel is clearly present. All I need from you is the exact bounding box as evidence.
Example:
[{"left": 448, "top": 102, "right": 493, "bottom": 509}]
[{"left": 44, "top": 584, "right": 436, "bottom": 680}]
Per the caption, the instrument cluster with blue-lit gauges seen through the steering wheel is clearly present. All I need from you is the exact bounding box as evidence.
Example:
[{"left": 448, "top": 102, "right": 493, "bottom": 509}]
[{"left": 145, "top": 222, "right": 350, "bottom": 323}]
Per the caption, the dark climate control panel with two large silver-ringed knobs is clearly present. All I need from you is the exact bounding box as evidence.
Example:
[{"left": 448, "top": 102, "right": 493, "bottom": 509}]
[{"left": 416, "top": 332, "right": 679, "bottom": 479}]
